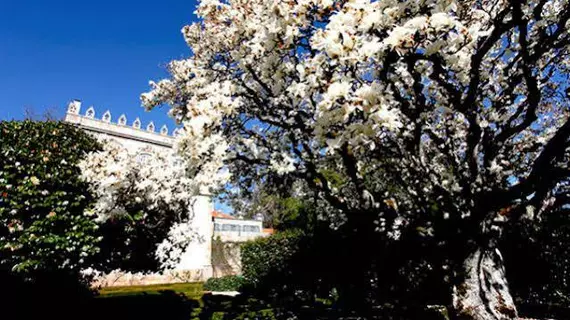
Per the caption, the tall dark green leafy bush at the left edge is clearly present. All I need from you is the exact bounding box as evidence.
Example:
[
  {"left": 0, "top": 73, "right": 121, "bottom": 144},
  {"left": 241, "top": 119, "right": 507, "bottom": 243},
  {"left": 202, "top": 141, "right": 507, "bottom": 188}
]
[{"left": 0, "top": 121, "right": 100, "bottom": 274}]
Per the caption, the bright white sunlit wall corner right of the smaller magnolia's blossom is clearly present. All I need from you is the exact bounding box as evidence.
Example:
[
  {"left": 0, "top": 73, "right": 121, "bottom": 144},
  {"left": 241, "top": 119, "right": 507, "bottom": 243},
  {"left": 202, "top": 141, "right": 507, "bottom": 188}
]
[{"left": 176, "top": 195, "right": 214, "bottom": 280}]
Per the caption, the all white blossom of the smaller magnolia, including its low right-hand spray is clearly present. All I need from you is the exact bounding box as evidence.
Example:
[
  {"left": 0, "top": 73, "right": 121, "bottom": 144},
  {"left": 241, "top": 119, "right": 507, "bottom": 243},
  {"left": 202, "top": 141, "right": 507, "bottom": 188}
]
[{"left": 79, "top": 141, "right": 228, "bottom": 269}]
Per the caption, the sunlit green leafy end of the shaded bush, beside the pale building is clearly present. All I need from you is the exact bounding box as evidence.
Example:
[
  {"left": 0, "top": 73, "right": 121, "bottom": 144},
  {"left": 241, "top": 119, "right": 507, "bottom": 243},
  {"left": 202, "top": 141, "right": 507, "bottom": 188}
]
[{"left": 241, "top": 229, "right": 304, "bottom": 285}]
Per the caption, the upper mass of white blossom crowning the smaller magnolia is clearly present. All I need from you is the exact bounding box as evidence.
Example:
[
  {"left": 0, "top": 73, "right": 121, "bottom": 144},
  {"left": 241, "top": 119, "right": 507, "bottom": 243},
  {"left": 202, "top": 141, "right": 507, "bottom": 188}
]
[{"left": 79, "top": 141, "right": 196, "bottom": 221}]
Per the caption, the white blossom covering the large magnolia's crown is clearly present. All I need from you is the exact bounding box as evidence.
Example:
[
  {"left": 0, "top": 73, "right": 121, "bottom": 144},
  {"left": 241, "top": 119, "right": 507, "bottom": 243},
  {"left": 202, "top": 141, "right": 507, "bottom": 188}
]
[{"left": 141, "top": 0, "right": 568, "bottom": 228}]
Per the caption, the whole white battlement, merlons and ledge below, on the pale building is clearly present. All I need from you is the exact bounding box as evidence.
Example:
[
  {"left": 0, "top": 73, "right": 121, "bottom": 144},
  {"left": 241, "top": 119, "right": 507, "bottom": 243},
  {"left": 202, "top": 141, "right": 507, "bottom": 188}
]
[{"left": 65, "top": 100, "right": 178, "bottom": 148}]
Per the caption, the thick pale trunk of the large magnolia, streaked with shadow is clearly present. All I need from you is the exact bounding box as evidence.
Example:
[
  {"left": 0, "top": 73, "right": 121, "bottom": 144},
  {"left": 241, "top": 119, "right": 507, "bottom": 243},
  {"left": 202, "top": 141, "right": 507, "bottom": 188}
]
[{"left": 453, "top": 248, "right": 517, "bottom": 320}]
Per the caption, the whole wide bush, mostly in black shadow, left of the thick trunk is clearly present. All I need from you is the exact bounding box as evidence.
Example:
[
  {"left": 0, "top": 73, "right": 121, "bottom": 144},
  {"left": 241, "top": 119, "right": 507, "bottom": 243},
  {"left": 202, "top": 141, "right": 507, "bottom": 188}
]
[{"left": 241, "top": 216, "right": 448, "bottom": 312}]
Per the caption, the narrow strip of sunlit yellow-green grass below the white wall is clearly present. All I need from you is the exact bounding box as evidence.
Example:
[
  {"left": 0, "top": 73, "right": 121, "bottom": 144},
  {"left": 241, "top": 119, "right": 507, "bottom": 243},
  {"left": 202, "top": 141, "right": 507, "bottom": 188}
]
[{"left": 99, "top": 282, "right": 203, "bottom": 300}]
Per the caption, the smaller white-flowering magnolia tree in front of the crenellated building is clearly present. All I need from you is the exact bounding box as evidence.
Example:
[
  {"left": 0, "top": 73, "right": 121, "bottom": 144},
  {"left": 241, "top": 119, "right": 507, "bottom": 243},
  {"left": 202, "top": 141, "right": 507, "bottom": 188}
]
[{"left": 79, "top": 141, "right": 209, "bottom": 269}]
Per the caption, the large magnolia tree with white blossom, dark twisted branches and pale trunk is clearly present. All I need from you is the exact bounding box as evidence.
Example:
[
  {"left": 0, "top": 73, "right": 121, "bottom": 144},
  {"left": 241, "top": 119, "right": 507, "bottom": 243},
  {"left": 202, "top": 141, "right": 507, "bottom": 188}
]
[{"left": 142, "top": 0, "right": 570, "bottom": 319}]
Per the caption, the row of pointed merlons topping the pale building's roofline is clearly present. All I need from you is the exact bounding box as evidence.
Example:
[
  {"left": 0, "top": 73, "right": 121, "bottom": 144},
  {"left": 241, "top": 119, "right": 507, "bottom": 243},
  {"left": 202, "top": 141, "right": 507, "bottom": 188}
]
[{"left": 67, "top": 100, "right": 180, "bottom": 137}]
